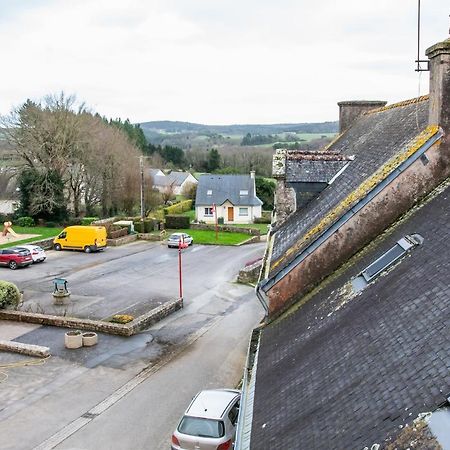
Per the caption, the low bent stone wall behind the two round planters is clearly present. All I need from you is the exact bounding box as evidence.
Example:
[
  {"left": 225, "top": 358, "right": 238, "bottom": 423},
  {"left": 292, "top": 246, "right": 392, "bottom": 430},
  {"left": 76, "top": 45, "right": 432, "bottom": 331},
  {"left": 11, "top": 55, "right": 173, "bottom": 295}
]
[{"left": 0, "top": 299, "right": 183, "bottom": 336}]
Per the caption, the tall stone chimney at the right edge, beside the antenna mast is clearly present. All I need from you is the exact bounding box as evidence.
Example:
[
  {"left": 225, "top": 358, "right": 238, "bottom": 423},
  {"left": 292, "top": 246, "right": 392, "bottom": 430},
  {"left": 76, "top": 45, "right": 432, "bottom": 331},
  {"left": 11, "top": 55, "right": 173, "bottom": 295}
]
[{"left": 425, "top": 38, "right": 450, "bottom": 136}]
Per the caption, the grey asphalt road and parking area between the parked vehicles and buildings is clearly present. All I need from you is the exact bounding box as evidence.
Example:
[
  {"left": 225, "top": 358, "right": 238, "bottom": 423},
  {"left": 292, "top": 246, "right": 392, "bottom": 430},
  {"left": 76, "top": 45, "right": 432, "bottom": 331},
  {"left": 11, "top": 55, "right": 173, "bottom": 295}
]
[{"left": 0, "top": 243, "right": 264, "bottom": 450}]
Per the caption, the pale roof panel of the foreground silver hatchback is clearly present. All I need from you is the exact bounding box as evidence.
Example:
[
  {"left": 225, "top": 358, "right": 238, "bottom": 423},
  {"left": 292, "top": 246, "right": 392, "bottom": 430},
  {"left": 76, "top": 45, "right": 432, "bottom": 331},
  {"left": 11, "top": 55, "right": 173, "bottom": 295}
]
[{"left": 186, "top": 389, "right": 240, "bottom": 419}]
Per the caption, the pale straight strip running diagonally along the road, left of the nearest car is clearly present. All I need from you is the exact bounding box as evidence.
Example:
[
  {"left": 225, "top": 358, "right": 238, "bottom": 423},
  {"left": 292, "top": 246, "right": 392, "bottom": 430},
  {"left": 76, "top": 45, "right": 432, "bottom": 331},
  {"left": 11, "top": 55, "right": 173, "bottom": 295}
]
[{"left": 33, "top": 316, "right": 224, "bottom": 450}]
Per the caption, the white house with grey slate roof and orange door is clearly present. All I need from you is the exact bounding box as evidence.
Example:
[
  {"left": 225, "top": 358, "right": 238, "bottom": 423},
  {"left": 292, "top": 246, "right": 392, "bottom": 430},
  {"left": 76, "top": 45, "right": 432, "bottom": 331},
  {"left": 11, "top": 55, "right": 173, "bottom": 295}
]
[{"left": 195, "top": 171, "right": 262, "bottom": 224}]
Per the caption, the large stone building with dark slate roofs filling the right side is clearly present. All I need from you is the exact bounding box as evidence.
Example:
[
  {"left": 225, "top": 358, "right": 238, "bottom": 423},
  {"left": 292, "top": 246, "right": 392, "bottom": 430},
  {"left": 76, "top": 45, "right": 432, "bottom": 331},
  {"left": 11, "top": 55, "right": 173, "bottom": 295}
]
[{"left": 235, "top": 39, "right": 450, "bottom": 450}]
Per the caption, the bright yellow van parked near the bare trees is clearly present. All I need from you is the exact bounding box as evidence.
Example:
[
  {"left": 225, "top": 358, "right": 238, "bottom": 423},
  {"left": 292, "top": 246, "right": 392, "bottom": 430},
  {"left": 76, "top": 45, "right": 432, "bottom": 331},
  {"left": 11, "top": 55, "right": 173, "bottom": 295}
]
[{"left": 53, "top": 225, "right": 106, "bottom": 253}]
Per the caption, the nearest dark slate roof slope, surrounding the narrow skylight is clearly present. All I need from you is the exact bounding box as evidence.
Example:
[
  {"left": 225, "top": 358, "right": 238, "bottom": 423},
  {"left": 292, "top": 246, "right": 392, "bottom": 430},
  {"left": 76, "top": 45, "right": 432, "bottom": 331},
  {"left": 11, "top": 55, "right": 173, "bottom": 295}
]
[{"left": 251, "top": 179, "right": 450, "bottom": 450}]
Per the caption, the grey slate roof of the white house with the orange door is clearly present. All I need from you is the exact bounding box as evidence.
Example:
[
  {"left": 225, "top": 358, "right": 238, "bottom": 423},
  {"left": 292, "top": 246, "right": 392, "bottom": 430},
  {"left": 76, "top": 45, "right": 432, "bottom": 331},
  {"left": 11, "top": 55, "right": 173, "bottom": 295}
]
[{"left": 195, "top": 174, "right": 262, "bottom": 206}]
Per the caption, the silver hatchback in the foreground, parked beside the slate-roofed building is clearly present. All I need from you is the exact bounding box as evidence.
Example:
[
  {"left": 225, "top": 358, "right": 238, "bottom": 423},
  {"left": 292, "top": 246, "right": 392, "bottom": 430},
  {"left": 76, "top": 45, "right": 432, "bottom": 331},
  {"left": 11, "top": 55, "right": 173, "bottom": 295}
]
[{"left": 171, "top": 389, "right": 241, "bottom": 450}]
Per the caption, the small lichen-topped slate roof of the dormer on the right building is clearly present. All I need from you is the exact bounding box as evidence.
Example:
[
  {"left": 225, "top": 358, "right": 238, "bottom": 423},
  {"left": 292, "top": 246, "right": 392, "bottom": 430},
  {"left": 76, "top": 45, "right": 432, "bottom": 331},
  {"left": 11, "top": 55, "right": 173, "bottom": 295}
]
[{"left": 286, "top": 151, "right": 351, "bottom": 183}]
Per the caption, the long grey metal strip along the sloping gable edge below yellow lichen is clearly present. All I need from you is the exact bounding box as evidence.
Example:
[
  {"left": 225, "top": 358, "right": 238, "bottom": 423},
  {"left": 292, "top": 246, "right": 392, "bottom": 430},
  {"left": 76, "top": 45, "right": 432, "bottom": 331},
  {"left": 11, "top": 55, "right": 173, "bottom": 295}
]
[{"left": 255, "top": 131, "right": 443, "bottom": 301}]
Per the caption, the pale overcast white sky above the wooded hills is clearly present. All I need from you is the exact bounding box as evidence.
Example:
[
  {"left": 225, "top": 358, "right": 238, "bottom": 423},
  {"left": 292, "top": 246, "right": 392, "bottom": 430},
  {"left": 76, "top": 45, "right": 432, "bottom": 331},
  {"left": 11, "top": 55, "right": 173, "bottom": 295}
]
[{"left": 0, "top": 0, "right": 450, "bottom": 124}]
